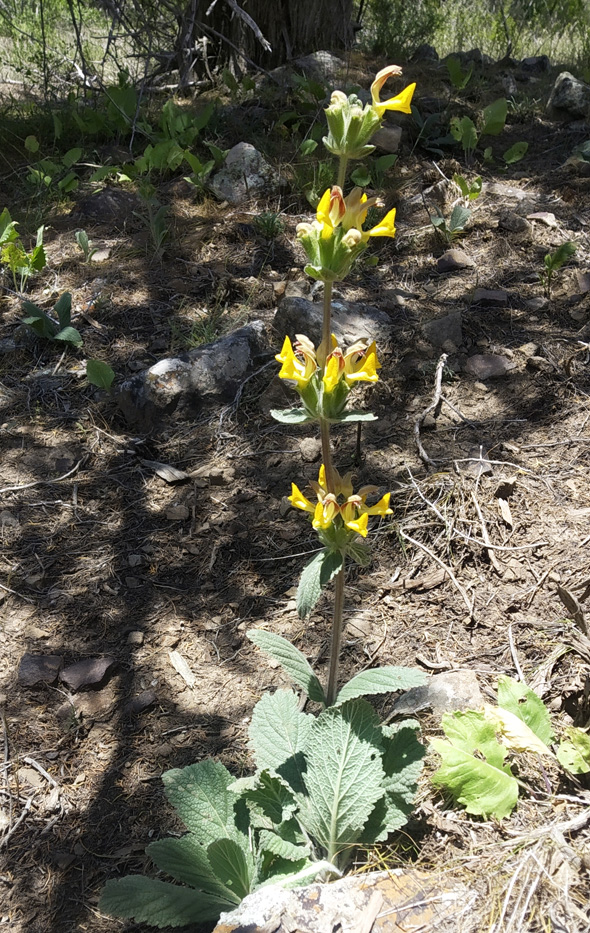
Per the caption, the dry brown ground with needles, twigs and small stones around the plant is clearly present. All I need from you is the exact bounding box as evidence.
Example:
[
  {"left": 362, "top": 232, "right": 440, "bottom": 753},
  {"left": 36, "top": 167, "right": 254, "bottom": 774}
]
[{"left": 0, "top": 47, "right": 590, "bottom": 933}]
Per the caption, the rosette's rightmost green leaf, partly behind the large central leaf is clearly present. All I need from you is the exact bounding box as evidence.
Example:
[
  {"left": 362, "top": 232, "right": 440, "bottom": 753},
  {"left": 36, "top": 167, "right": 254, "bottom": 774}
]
[{"left": 362, "top": 721, "right": 426, "bottom": 845}]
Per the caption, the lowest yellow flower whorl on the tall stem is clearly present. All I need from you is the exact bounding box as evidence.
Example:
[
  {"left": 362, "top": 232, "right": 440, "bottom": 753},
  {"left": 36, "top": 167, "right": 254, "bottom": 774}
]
[{"left": 289, "top": 463, "right": 392, "bottom": 557}]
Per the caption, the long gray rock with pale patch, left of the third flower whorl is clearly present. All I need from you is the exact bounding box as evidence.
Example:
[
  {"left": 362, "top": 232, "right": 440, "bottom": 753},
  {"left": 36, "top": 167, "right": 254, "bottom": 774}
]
[{"left": 116, "top": 321, "right": 264, "bottom": 432}]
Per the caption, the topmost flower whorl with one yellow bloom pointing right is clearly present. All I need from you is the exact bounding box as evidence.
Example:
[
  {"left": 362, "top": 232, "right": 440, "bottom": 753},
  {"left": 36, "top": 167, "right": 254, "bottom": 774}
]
[{"left": 323, "top": 65, "right": 416, "bottom": 159}]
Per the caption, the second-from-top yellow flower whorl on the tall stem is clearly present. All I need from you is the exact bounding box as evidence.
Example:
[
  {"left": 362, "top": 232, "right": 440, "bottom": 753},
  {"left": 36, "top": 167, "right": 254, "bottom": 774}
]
[{"left": 297, "top": 185, "right": 395, "bottom": 282}]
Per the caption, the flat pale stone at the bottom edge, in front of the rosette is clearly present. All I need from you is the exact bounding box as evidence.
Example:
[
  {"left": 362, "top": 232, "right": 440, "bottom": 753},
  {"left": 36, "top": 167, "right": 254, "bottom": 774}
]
[{"left": 214, "top": 868, "right": 478, "bottom": 933}]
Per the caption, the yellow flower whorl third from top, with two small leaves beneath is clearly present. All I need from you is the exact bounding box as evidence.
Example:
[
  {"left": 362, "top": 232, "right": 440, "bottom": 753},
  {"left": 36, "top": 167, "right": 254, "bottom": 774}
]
[{"left": 272, "top": 334, "right": 381, "bottom": 422}]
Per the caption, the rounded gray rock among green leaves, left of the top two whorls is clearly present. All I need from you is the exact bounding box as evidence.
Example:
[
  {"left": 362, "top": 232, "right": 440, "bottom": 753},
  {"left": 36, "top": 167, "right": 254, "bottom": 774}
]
[{"left": 209, "top": 143, "right": 280, "bottom": 204}]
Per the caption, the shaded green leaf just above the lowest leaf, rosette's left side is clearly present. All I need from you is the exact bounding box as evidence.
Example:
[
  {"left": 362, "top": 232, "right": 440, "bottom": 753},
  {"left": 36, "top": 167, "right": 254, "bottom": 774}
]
[{"left": 146, "top": 833, "right": 240, "bottom": 904}]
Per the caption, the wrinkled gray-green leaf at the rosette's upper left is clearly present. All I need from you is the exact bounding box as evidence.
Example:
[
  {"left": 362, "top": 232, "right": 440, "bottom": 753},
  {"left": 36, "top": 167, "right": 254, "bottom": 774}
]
[{"left": 162, "top": 759, "right": 243, "bottom": 845}]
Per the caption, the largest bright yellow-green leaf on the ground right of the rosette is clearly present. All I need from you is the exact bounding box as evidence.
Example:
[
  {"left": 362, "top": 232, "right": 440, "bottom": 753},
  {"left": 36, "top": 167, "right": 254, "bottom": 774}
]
[{"left": 431, "top": 710, "right": 518, "bottom": 819}]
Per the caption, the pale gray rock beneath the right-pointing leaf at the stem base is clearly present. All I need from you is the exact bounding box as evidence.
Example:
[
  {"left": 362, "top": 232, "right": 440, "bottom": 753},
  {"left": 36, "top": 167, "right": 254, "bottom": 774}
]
[{"left": 392, "top": 671, "right": 484, "bottom": 716}]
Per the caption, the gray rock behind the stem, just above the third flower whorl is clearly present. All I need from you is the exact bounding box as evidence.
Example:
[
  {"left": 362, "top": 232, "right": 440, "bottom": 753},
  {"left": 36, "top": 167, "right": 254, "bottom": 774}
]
[{"left": 273, "top": 298, "right": 391, "bottom": 346}]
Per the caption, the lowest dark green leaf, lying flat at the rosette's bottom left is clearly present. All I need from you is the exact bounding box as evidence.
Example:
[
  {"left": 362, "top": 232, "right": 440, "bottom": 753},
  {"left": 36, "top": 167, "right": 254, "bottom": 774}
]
[{"left": 98, "top": 875, "right": 228, "bottom": 929}]
